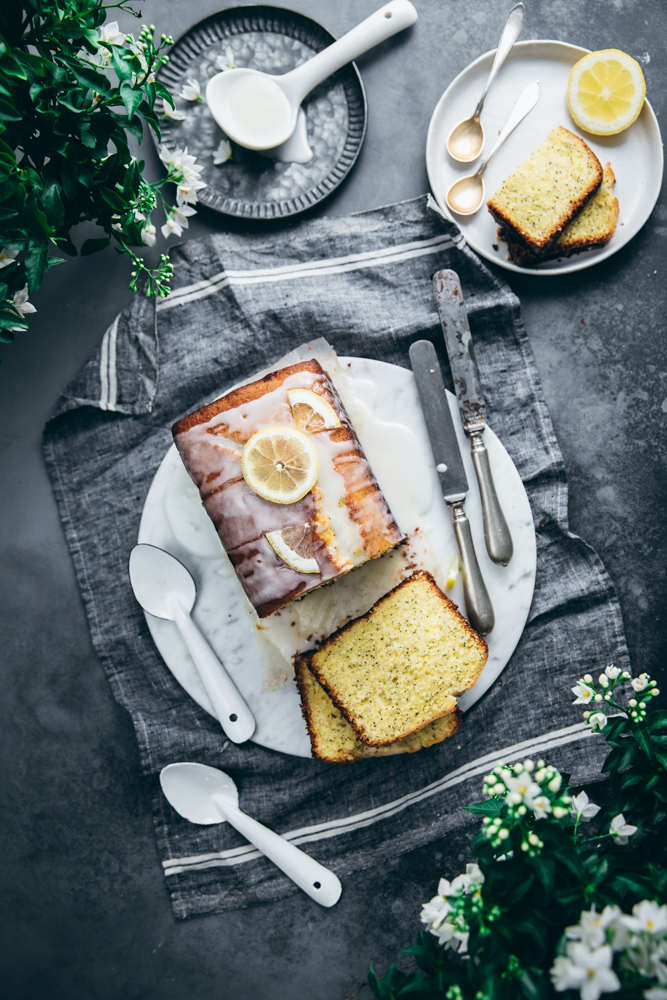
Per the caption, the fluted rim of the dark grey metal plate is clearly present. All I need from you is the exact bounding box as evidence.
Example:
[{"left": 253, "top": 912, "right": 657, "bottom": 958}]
[{"left": 151, "top": 3, "right": 368, "bottom": 222}]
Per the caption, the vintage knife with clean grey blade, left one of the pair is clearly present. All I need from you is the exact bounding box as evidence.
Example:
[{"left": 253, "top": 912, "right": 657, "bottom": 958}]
[{"left": 410, "top": 340, "right": 495, "bottom": 635}]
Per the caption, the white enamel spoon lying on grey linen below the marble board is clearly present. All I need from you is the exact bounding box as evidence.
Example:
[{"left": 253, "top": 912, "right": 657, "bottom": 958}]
[{"left": 160, "top": 763, "right": 343, "bottom": 906}]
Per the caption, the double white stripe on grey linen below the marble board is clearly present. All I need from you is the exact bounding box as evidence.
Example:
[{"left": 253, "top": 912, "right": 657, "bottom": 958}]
[{"left": 162, "top": 723, "right": 593, "bottom": 875}]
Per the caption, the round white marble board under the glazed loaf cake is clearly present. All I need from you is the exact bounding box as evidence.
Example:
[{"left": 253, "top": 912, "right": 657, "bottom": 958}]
[{"left": 138, "top": 358, "right": 536, "bottom": 757}]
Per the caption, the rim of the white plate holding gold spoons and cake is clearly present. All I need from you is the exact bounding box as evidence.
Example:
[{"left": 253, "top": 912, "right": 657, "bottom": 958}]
[{"left": 426, "top": 38, "right": 664, "bottom": 277}]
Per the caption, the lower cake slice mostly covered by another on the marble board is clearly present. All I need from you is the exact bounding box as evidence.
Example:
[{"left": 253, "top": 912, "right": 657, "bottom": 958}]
[{"left": 294, "top": 653, "right": 461, "bottom": 763}]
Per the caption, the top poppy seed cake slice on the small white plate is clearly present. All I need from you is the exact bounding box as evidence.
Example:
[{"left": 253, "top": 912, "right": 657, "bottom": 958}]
[{"left": 487, "top": 126, "right": 602, "bottom": 254}]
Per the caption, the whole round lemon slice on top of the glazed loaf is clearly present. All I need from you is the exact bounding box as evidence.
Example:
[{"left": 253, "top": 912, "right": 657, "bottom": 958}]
[{"left": 241, "top": 427, "right": 320, "bottom": 503}]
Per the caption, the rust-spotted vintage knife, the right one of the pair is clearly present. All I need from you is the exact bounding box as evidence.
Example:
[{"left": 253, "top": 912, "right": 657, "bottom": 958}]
[{"left": 433, "top": 271, "right": 514, "bottom": 566}]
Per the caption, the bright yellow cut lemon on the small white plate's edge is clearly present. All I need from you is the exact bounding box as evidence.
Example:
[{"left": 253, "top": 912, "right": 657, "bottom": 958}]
[{"left": 567, "top": 49, "right": 646, "bottom": 135}]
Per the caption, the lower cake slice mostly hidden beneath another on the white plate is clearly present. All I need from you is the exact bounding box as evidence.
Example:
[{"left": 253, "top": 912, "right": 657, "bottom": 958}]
[{"left": 498, "top": 163, "right": 618, "bottom": 267}]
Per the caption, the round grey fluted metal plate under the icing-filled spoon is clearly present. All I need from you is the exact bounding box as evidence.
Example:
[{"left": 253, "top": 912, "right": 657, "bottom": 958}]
[{"left": 158, "top": 5, "right": 366, "bottom": 219}]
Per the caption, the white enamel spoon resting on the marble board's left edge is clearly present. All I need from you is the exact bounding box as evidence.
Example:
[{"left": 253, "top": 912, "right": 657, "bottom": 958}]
[{"left": 130, "top": 545, "right": 255, "bottom": 743}]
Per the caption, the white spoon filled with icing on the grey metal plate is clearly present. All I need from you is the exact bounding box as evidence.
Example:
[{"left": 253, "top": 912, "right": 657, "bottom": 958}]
[{"left": 206, "top": 0, "right": 417, "bottom": 150}]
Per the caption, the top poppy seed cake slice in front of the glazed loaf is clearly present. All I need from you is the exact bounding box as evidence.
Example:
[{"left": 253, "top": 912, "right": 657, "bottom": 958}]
[{"left": 308, "top": 570, "right": 488, "bottom": 747}]
